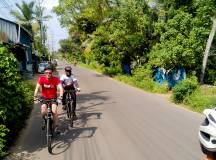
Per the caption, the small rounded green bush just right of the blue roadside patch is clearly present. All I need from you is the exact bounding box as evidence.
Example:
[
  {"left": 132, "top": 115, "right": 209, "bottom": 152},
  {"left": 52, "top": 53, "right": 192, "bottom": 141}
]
[{"left": 172, "top": 77, "right": 198, "bottom": 103}]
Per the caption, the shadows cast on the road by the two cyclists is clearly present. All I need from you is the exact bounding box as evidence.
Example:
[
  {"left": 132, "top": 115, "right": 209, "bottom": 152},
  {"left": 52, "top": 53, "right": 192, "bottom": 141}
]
[{"left": 49, "top": 91, "right": 109, "bottom": 155}]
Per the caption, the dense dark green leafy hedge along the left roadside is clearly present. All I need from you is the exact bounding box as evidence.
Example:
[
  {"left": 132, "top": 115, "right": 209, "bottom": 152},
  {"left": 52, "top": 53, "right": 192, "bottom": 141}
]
[{"left": 0, "top": 47, "right": 33, "bottom": 157}]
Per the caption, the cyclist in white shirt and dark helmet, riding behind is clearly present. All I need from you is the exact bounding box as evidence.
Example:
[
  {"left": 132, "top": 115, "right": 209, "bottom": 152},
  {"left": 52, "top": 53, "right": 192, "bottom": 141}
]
[{"left": 60, "top": 66, "right": 80, "bottom": 119}]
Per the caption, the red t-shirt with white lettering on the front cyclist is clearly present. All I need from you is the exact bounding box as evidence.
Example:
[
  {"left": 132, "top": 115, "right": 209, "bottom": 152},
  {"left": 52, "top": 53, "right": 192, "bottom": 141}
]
[{"left": 38, "top": 76, "right": 60, "bottom": 99}]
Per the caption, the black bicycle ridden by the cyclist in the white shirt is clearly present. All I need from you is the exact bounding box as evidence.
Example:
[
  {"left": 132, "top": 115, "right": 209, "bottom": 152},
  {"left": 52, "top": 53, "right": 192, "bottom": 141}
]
[{"left": 65, "top": 89, "right": 76, "bottom": 127}]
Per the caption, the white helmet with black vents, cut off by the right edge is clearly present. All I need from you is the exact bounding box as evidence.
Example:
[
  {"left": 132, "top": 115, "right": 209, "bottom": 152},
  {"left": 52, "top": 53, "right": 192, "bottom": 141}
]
[{"left": 199, "top": 108, "right": 216, "bottom": 154}]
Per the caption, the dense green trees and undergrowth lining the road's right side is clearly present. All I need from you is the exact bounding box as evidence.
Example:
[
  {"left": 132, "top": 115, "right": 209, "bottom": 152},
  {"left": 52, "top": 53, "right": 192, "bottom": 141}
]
[{"left": 53, "top": 0, "right": 216, "bottom": 111}]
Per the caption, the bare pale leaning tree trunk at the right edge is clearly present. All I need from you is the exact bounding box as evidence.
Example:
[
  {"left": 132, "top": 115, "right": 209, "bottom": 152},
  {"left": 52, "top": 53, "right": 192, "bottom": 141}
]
[{"left": 200, "top": 18, "right": 216, "bottom": 84}]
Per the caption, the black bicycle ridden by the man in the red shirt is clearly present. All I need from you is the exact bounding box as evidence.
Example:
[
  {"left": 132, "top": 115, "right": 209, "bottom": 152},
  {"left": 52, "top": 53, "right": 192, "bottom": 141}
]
[{"left": 38, "top": 98, "right": 57, "bottom": 153}]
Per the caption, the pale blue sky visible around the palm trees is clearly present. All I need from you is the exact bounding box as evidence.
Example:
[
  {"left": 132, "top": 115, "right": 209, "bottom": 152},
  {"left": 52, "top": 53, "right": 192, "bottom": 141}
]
[{"left": 0, "top": 0, "right": 68, "bottom": 51}]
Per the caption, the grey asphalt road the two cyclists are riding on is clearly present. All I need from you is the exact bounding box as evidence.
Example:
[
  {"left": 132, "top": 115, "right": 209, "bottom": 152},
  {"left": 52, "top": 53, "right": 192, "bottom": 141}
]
[{"left": 7, "top": 60, "right": 203, "bottom": 160}]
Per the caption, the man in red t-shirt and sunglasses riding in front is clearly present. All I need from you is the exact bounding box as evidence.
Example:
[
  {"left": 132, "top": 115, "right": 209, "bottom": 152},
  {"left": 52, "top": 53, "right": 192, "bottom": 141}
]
[{"left": 34, "top": 66, "right": 63, "bottom": 131}]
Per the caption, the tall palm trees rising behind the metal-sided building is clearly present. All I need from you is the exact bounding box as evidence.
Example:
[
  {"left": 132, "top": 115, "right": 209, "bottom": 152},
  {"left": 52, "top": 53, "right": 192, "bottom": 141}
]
[{"left": 11, "top": 1, "right": 51, "bottom": 57}]
